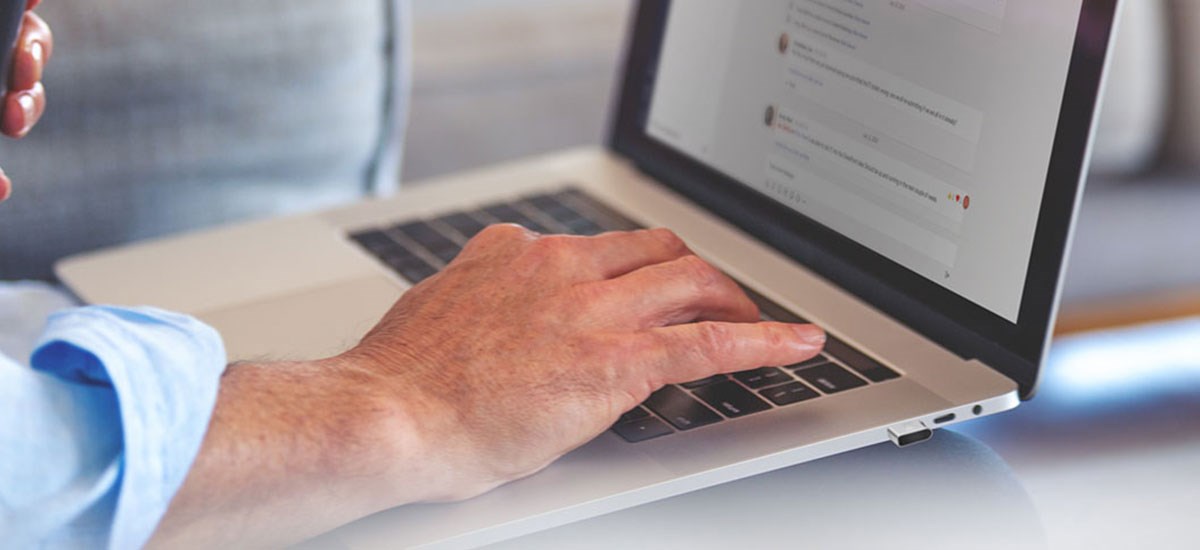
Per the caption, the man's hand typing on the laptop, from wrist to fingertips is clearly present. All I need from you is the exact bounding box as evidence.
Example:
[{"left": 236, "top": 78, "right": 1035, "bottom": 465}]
[{"left": 342, "top": 225, "right": 824, "bottom": 500}]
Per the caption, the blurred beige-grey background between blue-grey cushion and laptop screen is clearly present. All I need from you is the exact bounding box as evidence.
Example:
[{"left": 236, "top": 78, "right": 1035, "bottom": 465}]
[{"left": 403, "top": 0, "right": 631, "bottom": 181}]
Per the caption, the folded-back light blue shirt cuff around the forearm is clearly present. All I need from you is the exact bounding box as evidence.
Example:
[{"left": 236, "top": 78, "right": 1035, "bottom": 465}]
[{"left": 31, "top": 306, "right": 226, "bottom": 548}]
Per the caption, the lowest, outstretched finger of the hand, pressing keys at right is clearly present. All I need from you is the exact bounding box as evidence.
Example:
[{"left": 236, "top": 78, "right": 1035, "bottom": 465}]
[{"left": 646, "top": 322, "right": 826, "bottom": 384}]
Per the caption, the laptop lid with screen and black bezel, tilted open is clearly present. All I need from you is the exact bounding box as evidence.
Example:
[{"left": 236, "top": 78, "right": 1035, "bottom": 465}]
[{"left": 610, "top": 0, "right": 1118, "bottom": 399}]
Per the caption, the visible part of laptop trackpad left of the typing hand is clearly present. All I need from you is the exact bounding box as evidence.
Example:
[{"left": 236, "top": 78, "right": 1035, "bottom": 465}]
[{"left": 197, "top": 275, "right": 403, "bottom": 361}]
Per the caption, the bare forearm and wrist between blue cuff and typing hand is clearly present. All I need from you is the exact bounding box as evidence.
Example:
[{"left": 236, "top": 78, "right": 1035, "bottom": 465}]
[{"left": 151, "top": 359, "right": 438, "bottom": 548}]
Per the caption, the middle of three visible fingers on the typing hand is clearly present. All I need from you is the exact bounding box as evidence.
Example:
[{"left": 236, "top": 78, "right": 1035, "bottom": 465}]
[{"left": 588, "top": 256, "right": 758, "bottom": 330}]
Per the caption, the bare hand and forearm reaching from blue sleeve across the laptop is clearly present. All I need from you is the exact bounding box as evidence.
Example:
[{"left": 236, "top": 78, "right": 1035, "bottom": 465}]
[{"left": 151, "top": 226, "right": 824, "bottom": 548}]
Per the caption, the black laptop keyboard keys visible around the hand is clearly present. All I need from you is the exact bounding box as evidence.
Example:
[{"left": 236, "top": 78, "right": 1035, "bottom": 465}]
[{"left": 350, "top": 189, "right": 900, "bottom": 443}]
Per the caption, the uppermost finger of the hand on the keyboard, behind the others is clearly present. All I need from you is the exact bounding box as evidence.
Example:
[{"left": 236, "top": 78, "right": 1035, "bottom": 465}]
[{"left": 578, "top": 228, "right": 691, "bottom": 279}]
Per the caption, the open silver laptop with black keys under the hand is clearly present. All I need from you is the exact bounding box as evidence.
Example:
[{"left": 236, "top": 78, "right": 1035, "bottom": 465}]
[{"left": 58, "top": 0, "right": 1117, "bottom": 548}]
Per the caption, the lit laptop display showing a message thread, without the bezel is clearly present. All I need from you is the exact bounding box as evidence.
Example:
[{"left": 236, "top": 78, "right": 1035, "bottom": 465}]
[{"left": 643, "top": 0, "right": 1082, "bottom": 323}]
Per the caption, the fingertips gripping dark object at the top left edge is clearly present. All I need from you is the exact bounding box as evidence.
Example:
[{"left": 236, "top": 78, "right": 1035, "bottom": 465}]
[{"left": 0, "top": 0, "right": 54, "bottom": 202}]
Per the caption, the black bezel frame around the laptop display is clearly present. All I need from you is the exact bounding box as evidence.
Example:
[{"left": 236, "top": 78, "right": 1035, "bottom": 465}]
[{"left": 608, "top": 0, "right": 1120, "bottom": 399}]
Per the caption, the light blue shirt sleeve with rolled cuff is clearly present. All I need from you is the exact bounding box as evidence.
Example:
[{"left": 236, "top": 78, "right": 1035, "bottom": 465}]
[{"left": 0, "top": 285, "right": 226, "bottom": 549}]
